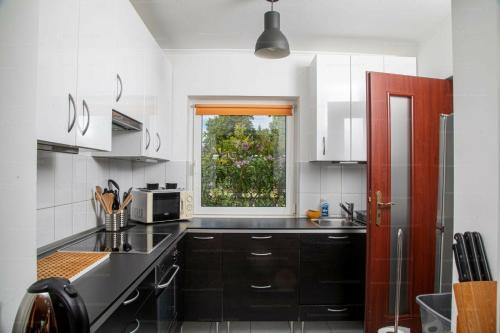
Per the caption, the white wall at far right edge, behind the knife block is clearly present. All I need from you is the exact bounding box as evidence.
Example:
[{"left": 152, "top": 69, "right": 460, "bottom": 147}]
[{"left": 452, "top": 0, "right": 500, "bottom": 327}]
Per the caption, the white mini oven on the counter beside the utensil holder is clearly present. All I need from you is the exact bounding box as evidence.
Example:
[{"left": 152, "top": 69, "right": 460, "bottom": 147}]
[{"left": 130, "top": 189, "right": 193, "bottom": 223}]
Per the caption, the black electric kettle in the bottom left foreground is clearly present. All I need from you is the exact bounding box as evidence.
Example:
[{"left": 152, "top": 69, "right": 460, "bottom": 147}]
[{"left": 12, "top": 278, "right": 90, "bottom": 333}]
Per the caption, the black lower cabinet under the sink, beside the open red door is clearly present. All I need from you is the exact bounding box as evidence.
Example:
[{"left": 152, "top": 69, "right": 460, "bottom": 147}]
[{"left": 300, "top": 233, "right": 366, "bottom": 321}]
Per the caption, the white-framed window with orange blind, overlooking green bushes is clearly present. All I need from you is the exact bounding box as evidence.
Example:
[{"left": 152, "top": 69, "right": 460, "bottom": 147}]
[{"left": 194, "top": 105, "right": 293, "bottom": 215}]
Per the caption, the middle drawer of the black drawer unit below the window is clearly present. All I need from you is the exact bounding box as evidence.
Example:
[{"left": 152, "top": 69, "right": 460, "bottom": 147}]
[{"left": 223, "top": 249, "right": 299, "bottom": 287}]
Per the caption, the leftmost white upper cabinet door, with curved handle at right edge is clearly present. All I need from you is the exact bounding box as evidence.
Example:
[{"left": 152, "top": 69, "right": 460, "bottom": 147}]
[{"left": 36, "top": 0, "right": 79, "bottom": 146}]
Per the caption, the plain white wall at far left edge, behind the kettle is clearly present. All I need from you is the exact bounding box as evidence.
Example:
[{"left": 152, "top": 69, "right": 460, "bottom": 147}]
[{"left": 0, "top": 0, "right": 38, "bottom": 332}]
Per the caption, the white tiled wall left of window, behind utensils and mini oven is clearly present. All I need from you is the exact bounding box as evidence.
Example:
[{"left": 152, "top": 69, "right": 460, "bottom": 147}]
[{"left": 37, "top": 151, "right": 186, "bottom": 247}]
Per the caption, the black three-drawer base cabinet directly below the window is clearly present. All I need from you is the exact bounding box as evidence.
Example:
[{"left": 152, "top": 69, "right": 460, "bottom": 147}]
[{"left": 223, "top": 233, "right": 299, "bottom": 321}]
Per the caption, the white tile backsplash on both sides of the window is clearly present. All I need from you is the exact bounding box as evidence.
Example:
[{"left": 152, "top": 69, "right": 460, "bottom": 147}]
[{"left": 37, "top": 151, "right": 366, "bottom": 247}]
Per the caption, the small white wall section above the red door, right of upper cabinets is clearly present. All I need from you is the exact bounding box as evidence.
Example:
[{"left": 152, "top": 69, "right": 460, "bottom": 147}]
[{"left": 417, "top": 11, "right": 453, "bottom": 79}]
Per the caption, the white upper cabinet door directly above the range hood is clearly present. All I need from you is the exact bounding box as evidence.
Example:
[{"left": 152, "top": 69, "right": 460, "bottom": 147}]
[{"left": 113, "top": 1, "right": 145, "bottom": 121}]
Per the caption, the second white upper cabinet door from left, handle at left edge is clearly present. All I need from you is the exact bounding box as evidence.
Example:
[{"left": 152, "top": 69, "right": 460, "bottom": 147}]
[{"left": 76, "top": 0, "right": 116, "bottom": 151}]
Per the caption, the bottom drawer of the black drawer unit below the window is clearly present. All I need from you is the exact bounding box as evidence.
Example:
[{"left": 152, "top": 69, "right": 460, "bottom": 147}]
[{"left": 224, "top": 284, "right": 298, "bottom": 321}]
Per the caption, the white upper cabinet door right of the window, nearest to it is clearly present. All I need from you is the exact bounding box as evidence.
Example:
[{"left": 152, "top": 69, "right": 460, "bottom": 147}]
[{"left": 316, "top": 55, "right": 351, "bottom": 161}]
